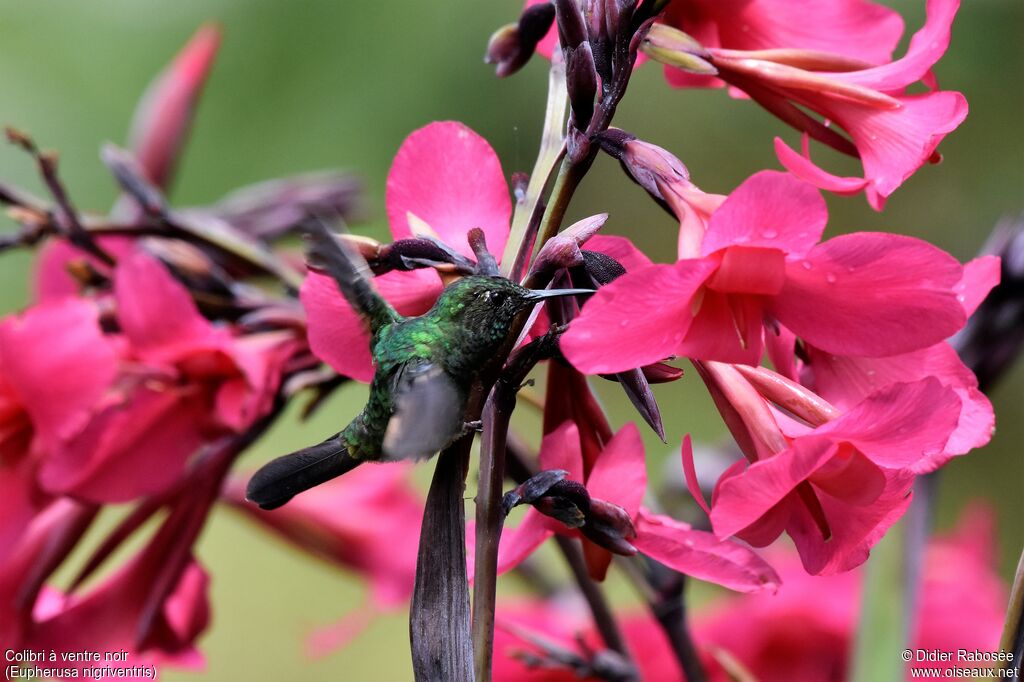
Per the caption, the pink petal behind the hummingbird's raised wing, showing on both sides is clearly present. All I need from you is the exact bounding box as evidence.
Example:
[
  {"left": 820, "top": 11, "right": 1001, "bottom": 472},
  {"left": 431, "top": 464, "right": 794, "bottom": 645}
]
[{"left": 299, "top": 270, "right": 442, "bottom": 383}]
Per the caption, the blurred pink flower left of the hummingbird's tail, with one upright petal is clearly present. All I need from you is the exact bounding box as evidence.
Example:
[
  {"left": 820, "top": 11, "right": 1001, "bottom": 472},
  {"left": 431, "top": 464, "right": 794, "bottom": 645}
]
[{"left": 39, "top": 252, "right": 295, "bottom": 502}]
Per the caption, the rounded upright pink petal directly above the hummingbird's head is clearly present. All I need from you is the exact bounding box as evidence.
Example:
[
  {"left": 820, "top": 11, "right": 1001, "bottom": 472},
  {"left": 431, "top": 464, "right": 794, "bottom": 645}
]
[{"left": 387, "top": 121, "right": 512, "bottom": 255}]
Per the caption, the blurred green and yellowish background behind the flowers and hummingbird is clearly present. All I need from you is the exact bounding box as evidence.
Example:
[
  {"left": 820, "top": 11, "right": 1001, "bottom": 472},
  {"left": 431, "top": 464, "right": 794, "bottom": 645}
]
[{"left": 0, "top": 0, "right": 1024, "bottom": 680}]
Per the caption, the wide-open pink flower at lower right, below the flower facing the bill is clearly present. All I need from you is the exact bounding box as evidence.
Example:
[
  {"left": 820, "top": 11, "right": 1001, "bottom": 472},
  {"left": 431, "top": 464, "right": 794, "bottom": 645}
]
[{"left": 683, "top": 364, "right": 961, "bottom": 574}]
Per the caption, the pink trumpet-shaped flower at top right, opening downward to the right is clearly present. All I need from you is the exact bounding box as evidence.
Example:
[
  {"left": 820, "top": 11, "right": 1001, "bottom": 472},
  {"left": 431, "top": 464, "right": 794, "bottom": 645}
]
[{"left": 688, "top": 0, "right": 967, "bottom": 210}]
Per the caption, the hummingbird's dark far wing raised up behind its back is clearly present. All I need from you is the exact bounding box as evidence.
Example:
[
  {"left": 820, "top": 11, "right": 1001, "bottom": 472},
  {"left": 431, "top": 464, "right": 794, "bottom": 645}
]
[{"left": 306, "top": 219, "right": 401, "bottom": 334}]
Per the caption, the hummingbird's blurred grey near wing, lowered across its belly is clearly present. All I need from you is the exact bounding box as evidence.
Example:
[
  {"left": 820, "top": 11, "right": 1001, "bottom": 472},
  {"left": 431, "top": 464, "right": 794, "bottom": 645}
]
[{"left": 383, "top": 359, "right": 466, "bottom": 460}]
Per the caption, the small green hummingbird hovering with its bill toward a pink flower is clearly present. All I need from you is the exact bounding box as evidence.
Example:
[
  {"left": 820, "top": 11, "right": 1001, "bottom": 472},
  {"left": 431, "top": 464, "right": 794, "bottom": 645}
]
[{"left": 246, "top": 221, "right": 594, "bottom": 509}]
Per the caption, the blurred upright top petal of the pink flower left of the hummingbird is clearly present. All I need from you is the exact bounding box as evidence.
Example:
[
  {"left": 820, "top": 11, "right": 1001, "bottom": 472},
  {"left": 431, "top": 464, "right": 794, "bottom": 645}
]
[{"left": 114, "top": 251, "right": 215, "bottom": 361}]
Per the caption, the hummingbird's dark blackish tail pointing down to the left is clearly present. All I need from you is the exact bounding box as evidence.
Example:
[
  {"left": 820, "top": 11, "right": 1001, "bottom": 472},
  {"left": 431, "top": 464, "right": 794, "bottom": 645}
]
[{"left": 246, "top": 434, "right": 362, "bottom": 510}]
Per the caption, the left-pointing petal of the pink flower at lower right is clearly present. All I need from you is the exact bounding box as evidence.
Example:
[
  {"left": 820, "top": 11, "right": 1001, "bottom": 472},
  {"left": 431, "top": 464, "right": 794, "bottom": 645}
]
[{"left": 711, "top": 436, "right": 836, "bottom": 538}]
